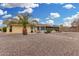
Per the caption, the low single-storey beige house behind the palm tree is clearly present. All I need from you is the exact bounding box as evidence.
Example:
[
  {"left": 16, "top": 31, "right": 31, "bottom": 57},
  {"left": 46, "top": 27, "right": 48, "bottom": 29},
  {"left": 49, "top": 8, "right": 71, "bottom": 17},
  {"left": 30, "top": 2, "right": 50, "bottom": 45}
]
[{"left": 7, "top": 24, "right": 51, "bottom": 34}]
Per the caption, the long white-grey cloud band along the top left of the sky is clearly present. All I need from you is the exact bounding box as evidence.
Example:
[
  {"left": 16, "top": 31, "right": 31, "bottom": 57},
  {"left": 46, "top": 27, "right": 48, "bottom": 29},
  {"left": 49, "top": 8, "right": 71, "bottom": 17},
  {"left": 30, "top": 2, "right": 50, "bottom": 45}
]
[{"left": 1, "top": 3, "right": 39, "bottom": 8}]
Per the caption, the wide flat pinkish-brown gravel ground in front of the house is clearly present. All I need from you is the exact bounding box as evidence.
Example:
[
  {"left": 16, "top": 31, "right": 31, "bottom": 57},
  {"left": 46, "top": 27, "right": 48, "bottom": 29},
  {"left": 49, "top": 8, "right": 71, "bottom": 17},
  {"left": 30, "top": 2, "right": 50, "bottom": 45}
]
[{"left": 0, "top": 32, "right": 79, "bottom": 56}]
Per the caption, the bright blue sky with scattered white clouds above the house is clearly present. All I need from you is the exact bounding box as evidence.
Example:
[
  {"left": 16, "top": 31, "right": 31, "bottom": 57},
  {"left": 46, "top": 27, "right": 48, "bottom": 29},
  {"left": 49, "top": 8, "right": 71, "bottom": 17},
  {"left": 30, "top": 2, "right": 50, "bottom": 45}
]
[{"left": 0, "top": 3, "right": 79, "bottom": 25}]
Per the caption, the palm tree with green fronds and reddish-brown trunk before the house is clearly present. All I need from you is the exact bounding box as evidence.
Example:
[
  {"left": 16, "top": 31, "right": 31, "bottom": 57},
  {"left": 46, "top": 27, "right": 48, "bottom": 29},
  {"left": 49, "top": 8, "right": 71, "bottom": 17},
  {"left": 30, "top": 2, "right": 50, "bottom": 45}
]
[{"left": 18, "top": 14, "right": 29, "bottom": 35}]
